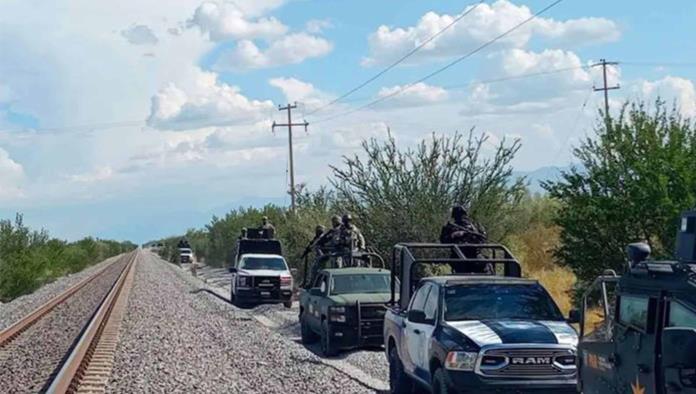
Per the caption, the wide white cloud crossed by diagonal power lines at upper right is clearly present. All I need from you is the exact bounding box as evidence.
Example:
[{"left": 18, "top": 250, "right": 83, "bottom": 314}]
[{"left": 363, "top": 0, "right": 620, "bottom": 66}]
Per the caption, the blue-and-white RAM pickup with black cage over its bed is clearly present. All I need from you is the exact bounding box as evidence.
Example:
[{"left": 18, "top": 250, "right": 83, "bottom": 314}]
[{"left": 384, "top": 244, "right": 577, "bottom": 393}]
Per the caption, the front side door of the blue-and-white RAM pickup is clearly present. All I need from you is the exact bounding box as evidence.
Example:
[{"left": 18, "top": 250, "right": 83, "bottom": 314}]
[{"left": 401, "top": 283, "right": 431, "bottom": 382}]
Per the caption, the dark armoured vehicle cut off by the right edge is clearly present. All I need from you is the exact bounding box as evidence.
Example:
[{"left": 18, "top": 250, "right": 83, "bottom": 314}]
[{"left": 578, "top": 211, "right": 696, "bottom": 394}]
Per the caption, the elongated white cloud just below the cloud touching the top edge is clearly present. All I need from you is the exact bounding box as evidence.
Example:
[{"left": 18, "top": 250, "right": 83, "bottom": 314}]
[{"left": 215, "top": 33, "right": 333, "bottom": 70}]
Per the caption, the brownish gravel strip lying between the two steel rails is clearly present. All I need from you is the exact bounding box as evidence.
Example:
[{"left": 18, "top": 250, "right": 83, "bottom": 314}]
[{"left": 0, "top": 256, "right": 128, "bottom": 393}]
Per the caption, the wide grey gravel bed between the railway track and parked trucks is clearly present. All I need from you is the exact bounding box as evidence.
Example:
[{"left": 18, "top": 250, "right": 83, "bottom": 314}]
[{"left": 107, "top": 252, "right": 374, "bottom": 393}]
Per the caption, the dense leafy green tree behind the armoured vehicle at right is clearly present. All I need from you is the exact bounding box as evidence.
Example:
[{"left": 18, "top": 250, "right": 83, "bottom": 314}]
[{"left": 544, "top": 100, "right": 696, "bottom": 281}]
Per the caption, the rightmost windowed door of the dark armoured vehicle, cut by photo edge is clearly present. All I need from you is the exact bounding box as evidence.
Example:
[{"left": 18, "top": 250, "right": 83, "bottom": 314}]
[{"left": 660, "top": 300, "right": 696, "bottom": 394}]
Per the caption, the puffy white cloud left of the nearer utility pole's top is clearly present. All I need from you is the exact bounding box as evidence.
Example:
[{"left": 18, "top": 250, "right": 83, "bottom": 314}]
[{"left": 148, "top": 67, "right": 273, "bottom": 130}]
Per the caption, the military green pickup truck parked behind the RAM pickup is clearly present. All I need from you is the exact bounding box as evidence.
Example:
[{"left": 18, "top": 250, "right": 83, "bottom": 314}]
[{"left": 299, "top": 267, "right": 391, "bottom": 357}]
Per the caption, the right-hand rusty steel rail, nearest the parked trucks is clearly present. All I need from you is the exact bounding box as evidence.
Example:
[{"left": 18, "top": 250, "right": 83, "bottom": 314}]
[{"left": 46, "top": 251, "right": 138, "bottom": 394}]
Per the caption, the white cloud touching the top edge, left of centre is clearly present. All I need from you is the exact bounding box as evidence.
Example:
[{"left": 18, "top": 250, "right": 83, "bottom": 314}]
[{"left": 188, "top": 2, "right": 288, "bottom": 41}]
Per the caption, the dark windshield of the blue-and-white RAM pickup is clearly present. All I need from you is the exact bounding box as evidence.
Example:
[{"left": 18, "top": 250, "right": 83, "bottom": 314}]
[{"left": 445, "top": 284, "right": 564, "bottom": 321}]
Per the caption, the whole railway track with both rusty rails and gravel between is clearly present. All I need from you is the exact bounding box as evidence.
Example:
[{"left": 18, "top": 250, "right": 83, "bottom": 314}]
[{"left": 0, "top": 251, "right": 138, "bottom": 393}]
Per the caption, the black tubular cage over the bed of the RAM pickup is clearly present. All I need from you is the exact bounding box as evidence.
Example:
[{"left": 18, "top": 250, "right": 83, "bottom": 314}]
[{"left": 391, "top": 243, "right": 522, "bottom": 309}]
